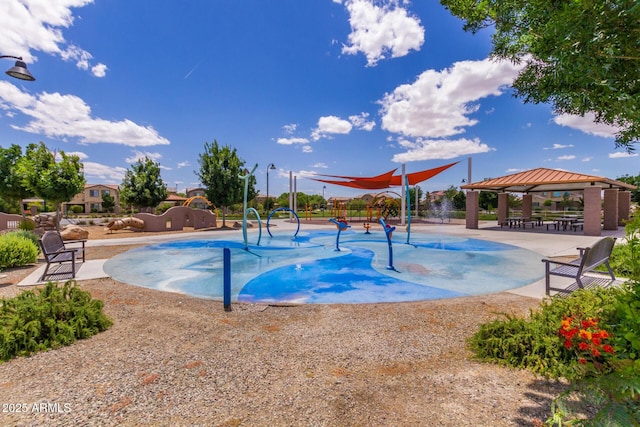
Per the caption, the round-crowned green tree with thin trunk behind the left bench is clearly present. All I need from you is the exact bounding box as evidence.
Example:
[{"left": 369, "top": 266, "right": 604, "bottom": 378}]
[{"left": 16, "top": 142, "right": 85, "bottom": 229}]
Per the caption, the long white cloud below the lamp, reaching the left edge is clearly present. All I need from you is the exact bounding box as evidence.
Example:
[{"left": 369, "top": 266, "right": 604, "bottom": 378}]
[{"left": 0, "top": 81, "right": 169, "bottom": 147}]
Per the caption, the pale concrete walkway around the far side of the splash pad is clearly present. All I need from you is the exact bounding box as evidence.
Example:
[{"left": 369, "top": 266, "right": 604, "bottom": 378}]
[{"left": 18, "top": 218, "right": 625, "bottom": 299}]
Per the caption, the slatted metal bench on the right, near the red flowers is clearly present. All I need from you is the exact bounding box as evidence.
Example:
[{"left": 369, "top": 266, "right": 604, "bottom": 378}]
[{"left": 542, "top": 237, "right": 616, "bottom": 295}]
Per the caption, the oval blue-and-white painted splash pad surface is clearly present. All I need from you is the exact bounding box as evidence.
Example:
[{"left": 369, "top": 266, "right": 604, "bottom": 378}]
[{"left": 104, "top": 230, "right": 543, "bottom": 303}]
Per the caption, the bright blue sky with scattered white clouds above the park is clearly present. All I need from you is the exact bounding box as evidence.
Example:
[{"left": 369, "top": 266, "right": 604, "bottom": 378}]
[{"left": 0, "top": 0, "right": 639, "bottom": 198}]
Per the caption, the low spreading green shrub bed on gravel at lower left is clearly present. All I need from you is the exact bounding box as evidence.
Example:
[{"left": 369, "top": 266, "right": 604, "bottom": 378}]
[{"left": 0, "top": 280, "right": 112, "bottom": 361}]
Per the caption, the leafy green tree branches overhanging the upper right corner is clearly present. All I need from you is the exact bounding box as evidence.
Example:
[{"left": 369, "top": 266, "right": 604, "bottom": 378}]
[{"left": 440, "top": 0, "right": 640, "bottom": 151}]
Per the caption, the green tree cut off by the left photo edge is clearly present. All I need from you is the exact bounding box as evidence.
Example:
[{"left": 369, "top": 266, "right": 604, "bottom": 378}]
[{"left": 0, "top": 144, "right": 33, "bottom": 216}]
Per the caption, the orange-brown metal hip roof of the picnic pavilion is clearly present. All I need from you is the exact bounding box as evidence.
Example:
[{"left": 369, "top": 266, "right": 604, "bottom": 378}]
[{"left": 460, "top": 168, "right": 636, "bottom": 193}]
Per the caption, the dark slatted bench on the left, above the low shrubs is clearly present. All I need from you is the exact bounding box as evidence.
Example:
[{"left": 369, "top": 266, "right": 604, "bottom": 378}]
[{"left": 40, "top": 231, "right": 86, "bottom": 281}]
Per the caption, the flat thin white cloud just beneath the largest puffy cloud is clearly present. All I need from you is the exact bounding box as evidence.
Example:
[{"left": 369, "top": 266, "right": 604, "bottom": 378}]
[{"left": 391, "top": 138, "right": 494, "bottom": 163}]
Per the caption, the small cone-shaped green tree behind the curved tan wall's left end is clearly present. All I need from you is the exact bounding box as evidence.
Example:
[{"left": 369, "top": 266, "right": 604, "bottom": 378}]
[{"left": 120, "top": 156, "right": 167, "bottom": 212}]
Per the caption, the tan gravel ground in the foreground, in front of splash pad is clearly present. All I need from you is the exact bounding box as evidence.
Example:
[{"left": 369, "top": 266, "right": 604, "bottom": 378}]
[{"left": 0, "top": 226, "right": 564, "bottom": 426}]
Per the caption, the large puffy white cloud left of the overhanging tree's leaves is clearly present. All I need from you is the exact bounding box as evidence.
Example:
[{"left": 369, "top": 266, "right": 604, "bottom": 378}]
[{"left": 378, "top": 59, "right": 519, "bottom": 138}]
